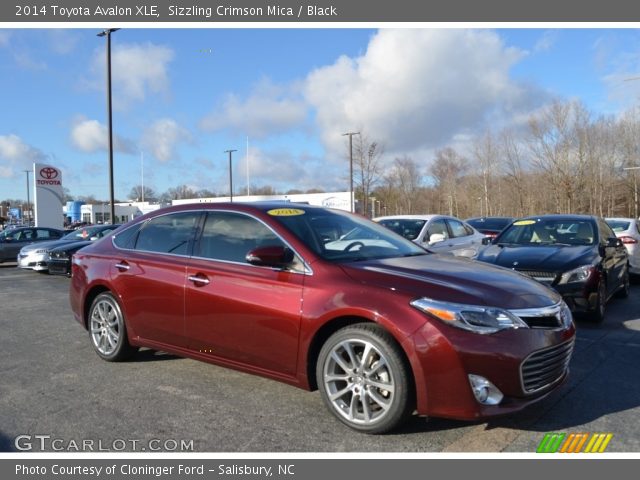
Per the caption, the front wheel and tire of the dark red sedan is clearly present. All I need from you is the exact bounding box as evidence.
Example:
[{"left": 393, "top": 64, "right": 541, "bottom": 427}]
[{"left": 316, "top": 323, "right": 415, "bottom": 434}]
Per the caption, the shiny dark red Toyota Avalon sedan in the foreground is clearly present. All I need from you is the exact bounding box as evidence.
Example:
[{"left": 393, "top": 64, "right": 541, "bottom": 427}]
[{"left": 70, "top": 203, "right": 575, "bottom": 433}]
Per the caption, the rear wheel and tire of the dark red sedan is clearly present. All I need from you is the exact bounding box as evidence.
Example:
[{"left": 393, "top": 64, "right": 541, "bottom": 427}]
[{"left": 87, "top": 292, "right": 138, "bottom": 362}]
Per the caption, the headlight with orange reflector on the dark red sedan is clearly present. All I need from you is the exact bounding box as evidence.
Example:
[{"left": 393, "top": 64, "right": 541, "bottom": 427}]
[{"left": 411, "top": 298, "right": 529, "bottom": 334}]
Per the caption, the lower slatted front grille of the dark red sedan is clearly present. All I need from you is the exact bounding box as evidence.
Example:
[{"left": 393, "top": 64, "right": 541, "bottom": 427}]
[{"left": 520, "top": 340, "right": 573, "bottom": 393}]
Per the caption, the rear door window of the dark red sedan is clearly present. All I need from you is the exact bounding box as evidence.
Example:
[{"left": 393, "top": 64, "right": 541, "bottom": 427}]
[{"left": 135, "top": 212, "right": 200, "bottom": 255}]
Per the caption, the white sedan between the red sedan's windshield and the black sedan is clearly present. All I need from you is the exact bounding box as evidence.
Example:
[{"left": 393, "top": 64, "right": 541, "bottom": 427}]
[{"left": 373, "top": 215, "right": 485, "bottom": 258}]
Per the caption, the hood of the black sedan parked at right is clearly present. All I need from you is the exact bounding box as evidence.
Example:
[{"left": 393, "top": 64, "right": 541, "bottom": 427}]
[{"left": 478, "top": 245, "right": 598, "bottom": 272}]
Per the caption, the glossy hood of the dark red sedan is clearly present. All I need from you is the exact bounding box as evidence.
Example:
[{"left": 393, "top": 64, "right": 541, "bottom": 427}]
[{"left": 342, "top": 254, "right": 561, "bottom": 309}]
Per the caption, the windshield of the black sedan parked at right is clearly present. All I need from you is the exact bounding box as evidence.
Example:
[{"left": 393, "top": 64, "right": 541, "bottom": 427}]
[{"left": 495, "top": 218, "right": 598, "bottom": 246}]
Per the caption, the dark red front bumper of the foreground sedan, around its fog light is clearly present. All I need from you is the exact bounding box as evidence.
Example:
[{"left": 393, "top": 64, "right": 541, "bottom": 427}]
[{"left": 411, "top": 321, "right": 575, "bottom": 420}]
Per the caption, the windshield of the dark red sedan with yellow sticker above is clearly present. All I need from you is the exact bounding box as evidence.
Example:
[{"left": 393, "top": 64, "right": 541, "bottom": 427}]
[{"left": 273, "top": 208, "right": 427, "bottom": 262}]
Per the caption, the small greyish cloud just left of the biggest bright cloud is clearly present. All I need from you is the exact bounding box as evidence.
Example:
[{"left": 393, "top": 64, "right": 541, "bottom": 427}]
[{"left": 200, "top": 80, "right": 307, "bottom": 138}]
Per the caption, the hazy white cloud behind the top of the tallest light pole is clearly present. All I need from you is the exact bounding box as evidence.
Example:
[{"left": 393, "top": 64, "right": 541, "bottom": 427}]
[{"left": 91, "top": 41, "right": 174, "bottom": 108}]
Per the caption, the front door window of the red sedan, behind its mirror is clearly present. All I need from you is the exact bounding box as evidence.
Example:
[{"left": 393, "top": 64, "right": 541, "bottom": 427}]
[{"left": 196, "top": 212, "right": 284, "bottom": 263}]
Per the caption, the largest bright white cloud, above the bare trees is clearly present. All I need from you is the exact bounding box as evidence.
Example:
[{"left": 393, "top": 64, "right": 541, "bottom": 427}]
[{"left": 305, "top": 29, "right": 539, "bottom": 153}]
